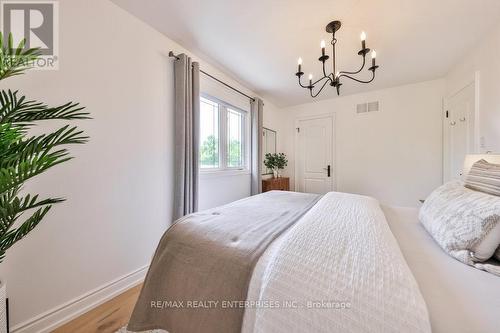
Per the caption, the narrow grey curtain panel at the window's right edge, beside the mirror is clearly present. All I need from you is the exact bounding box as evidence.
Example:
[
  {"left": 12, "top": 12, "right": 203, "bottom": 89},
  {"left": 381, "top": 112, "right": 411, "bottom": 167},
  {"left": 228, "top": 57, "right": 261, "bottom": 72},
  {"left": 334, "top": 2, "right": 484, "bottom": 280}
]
[{"left": 250, "top": 98, "right": 264, "bottom": 195}]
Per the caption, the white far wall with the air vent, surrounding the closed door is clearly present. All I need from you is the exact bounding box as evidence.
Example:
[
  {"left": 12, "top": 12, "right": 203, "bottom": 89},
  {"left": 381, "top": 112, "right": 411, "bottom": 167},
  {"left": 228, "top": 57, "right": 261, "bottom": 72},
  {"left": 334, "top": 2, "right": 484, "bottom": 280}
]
[{"left": 281, "top": 80, "right": 444, "bottom": 206}]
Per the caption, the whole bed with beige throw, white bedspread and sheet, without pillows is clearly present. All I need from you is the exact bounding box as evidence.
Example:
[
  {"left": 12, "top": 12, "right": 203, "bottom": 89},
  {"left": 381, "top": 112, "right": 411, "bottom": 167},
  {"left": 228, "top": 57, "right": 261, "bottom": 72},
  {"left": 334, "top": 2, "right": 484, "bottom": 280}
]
[{"left": 129, "top": 192, "right": 500, "bottom": 333}]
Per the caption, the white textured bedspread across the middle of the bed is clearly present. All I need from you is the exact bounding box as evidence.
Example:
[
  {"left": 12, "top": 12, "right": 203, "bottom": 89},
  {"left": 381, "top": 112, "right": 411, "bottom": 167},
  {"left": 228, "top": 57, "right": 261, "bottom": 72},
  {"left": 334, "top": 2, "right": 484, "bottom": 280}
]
[{"left": 243, "top": 193, "right": 431, "bottom": 333}]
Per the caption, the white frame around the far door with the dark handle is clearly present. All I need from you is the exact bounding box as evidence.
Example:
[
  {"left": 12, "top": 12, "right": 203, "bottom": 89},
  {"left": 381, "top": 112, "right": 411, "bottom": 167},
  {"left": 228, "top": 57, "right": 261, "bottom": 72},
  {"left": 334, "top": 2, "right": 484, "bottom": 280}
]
[{"left": 293, "top": 112, "right": 337, "bottom": 191}]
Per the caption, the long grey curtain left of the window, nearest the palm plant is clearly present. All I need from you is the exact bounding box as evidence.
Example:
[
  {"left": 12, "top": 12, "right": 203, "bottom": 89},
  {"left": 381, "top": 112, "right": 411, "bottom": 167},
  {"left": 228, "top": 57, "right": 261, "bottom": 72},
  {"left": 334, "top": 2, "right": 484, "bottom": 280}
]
[{"left": 173, "top": 54, "right": 200, "bottom": 219}]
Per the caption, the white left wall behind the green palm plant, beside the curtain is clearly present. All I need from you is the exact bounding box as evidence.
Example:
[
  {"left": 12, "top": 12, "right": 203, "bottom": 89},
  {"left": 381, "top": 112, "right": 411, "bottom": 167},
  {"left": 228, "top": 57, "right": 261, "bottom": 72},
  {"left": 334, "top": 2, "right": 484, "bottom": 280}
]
[{"left": 0, "top": 0, "right": 278, "bottom": 332}]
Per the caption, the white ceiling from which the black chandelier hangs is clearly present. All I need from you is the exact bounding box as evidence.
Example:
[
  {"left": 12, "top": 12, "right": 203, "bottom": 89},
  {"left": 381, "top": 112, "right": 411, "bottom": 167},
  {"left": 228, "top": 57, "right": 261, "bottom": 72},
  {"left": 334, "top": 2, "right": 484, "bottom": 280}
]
[{"left": 112, "top": 0, "right": 500, "bottom": 107}]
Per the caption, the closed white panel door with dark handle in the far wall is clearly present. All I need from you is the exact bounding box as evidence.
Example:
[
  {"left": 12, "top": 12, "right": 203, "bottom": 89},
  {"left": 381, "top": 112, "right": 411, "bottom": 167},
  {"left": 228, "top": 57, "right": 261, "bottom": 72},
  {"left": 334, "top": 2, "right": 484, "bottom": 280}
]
[{"left": 295, "top": 116, "right": 334, "bottom": 194}]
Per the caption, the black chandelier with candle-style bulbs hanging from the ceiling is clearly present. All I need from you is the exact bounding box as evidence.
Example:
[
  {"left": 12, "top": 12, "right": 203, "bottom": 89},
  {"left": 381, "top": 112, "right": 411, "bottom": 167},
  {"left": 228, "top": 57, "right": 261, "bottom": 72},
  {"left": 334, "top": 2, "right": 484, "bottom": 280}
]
[{"left": 295, "top": 21, "right": 378, "bottom": 98}]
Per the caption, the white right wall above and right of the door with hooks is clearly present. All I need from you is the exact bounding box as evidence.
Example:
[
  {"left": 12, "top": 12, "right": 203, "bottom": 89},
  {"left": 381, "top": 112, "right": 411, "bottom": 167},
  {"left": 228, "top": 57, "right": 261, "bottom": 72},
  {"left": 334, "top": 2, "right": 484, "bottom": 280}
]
[{"left": 446, "top": 25, "right": 500, "bottom": 153}]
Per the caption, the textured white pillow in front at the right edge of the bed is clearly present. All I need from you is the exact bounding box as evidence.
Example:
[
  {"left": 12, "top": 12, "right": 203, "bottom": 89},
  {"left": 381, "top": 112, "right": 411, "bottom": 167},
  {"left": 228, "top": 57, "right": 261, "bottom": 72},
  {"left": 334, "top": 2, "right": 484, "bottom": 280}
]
[{"left": 419, "top": 181, "right": 500, "bottom": 265}]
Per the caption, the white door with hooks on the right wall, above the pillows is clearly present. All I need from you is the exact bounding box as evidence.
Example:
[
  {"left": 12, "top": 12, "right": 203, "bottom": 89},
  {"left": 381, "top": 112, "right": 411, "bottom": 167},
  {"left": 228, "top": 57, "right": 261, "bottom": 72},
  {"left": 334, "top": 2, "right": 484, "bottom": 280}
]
[{"left": 444, "top": 84, "right": 475, "bottom": 181}]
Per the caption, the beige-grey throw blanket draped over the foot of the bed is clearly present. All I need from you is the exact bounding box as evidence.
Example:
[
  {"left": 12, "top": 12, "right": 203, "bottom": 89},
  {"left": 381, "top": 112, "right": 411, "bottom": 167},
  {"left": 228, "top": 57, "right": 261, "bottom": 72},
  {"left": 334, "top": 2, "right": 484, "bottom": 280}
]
[{"left": 128, "top": 191, "right": 320, "bottom": 333}]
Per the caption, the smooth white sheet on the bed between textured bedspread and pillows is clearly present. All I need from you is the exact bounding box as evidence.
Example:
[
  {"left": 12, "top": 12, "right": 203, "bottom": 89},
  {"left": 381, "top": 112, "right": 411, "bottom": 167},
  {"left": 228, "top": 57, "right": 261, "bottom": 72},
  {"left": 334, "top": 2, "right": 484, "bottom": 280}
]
[{"left": 382, "top": 206, "right": 500, "bottom": 333}]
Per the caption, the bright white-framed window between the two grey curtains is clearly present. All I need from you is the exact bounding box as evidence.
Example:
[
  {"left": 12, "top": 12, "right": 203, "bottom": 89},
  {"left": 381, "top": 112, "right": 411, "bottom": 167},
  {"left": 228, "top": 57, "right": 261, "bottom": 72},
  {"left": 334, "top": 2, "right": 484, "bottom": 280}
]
[{"left": 200, "top": 96, "right": 249, "bottom": 171}]
